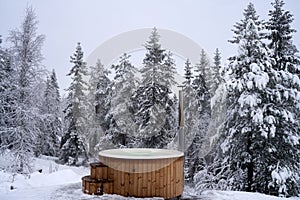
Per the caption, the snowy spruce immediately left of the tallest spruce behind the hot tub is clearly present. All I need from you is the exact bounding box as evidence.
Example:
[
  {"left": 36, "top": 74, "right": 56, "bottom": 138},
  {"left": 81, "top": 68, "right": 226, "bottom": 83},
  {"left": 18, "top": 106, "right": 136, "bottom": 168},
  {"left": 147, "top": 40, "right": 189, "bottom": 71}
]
[{"left": 107, "top": 53, "right": 138, "bottom": 147}]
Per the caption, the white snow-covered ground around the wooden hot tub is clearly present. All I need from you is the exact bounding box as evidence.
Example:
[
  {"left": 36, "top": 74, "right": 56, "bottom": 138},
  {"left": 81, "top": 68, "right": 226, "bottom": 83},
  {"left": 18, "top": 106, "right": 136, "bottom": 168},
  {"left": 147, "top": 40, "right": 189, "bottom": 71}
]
[{"left": 0, "top": 157, "right": 300, "bottom": 200}]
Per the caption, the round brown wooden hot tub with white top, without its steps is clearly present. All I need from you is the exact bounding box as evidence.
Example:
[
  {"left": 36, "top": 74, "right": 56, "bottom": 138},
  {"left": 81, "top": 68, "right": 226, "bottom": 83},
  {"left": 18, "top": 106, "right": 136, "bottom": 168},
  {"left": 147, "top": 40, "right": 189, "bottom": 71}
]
[{"left": 99, "top": 148, "right": 184, "bottom": 199}]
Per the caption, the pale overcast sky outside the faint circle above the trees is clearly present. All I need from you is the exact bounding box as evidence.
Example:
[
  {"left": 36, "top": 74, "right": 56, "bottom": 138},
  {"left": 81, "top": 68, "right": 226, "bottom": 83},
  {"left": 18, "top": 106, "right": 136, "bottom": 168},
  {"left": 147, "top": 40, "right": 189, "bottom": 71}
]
[{"left": 0, "top": 0, "right": 300, "bottom": 92}]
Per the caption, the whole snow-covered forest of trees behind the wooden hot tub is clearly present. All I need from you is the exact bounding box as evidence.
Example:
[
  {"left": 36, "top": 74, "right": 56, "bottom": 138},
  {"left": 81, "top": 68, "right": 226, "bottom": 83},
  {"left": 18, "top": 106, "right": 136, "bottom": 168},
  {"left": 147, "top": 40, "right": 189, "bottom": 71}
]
[{"left": 0, "top": 0, "right": 300, "bottom": 196}]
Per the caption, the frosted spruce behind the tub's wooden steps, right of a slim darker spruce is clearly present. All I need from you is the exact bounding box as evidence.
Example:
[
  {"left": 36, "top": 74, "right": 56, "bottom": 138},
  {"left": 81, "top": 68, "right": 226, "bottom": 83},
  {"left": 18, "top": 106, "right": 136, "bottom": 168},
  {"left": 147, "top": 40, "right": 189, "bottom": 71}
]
[{"left": 87, "top": 59, "right": 112, "bottom": 156}]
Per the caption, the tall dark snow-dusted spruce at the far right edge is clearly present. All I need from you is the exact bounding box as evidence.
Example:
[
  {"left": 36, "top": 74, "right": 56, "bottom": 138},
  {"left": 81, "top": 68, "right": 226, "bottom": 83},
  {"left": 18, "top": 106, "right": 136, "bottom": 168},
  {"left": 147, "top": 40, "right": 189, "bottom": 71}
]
[{"left": 263, "top": 0, "right": 300, "bottom": 196}]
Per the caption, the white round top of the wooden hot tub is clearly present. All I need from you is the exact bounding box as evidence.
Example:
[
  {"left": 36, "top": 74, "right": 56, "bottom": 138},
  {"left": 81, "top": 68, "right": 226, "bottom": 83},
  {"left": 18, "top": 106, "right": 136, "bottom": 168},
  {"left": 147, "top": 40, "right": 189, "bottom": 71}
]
[{"left": 99, "top": 148, "right": 184, "bottom": 160}]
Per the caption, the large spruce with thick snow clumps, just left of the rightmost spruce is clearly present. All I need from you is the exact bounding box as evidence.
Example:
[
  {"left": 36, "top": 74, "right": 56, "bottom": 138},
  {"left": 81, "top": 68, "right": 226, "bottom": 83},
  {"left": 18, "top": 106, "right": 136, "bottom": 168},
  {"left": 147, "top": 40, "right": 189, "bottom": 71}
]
[{"left": 221, "top": 3, "right": 280, "bottom": 192}]
